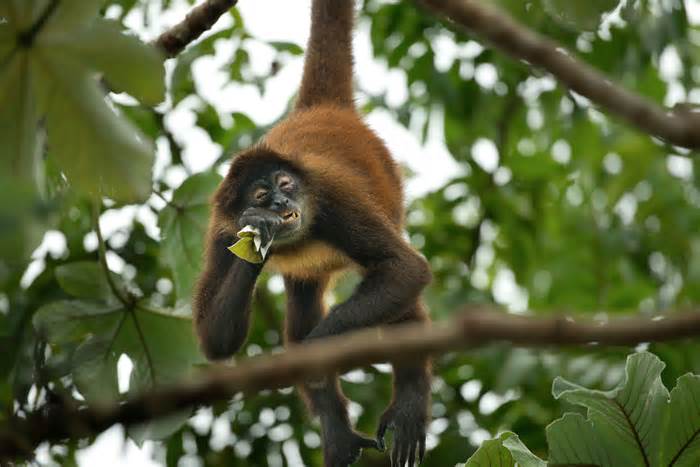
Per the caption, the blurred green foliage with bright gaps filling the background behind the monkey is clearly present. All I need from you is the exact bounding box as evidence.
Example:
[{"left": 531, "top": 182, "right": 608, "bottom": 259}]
[{"left": 0, "top": 0, "right": 700, "bottom": 466}]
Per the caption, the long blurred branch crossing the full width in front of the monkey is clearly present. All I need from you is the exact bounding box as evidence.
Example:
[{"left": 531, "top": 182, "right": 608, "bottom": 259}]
[{"left": 0, "top": 309, "right": 700, "bottom": 459}]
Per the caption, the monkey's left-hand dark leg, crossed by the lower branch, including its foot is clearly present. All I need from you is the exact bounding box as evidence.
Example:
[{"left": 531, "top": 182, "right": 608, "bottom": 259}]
[{"left": 284, "top": 277, "right": 377, "bottom": 467}]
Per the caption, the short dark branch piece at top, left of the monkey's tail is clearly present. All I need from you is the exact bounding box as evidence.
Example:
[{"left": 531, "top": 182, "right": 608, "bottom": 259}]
[{"left": 153, "top": 0, "right": 238, "bottom": 57}]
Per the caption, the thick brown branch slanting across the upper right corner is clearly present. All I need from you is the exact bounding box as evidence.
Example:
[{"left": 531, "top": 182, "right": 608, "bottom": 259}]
[{"left": 420, "top": 0, "right": 700, "bottom": 149}]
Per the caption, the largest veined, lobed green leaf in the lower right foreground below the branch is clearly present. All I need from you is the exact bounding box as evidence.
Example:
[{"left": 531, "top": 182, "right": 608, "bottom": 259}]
[{"left": 552, "top": 352, "right": 669, "bottom": 466}]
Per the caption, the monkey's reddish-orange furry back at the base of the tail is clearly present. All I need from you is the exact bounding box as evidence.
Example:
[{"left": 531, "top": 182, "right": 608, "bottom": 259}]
[{"left": 264, "top": 105, "right": 404, "bottom": 230}]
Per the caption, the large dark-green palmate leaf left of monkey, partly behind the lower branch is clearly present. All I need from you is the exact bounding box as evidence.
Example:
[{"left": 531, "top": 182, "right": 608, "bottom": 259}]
[{"left": 33, "top": 262, "right": 204, "bottom": 442}]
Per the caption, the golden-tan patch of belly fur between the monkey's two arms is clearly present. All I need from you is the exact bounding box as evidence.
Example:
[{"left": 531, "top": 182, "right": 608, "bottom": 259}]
[{"left": 267, "top": 239, "right": 353, "bottom": 279}]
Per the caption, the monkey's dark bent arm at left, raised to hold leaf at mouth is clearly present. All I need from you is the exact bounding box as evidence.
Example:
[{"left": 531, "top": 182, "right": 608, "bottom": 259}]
[{"left": 193, "top": 235, "right": 262, "bottom": 360}]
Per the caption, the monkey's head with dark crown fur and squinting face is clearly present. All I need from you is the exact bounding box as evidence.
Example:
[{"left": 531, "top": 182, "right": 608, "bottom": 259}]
[{"left": 215, "top": 147, "right": 311, "bottom": 243}]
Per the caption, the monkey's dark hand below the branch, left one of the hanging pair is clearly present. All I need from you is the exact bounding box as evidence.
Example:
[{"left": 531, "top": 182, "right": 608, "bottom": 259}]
[{"left": 321, "top": 417, "right": 379, "bottom": 467}]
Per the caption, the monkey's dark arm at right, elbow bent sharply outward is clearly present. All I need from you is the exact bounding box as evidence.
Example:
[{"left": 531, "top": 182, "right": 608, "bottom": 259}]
[{"left": 308, "top": 207, "right": 431, "bottom": 339}]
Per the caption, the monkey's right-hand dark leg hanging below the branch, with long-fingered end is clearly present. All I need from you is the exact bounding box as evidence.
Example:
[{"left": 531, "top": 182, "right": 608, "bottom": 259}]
[{"left": 377, "top": 302, "right": 431, "bottom": 467}]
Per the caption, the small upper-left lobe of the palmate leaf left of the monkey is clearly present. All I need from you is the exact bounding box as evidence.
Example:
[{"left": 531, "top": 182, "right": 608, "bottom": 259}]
[{"left": 55, "top": 261, "right": 113, "bottom": 300}]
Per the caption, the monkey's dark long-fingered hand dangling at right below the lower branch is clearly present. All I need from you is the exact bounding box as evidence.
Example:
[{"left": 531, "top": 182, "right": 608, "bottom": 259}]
[{"left": 377, "top": 390, "right": 428, "bottom": 467}]
